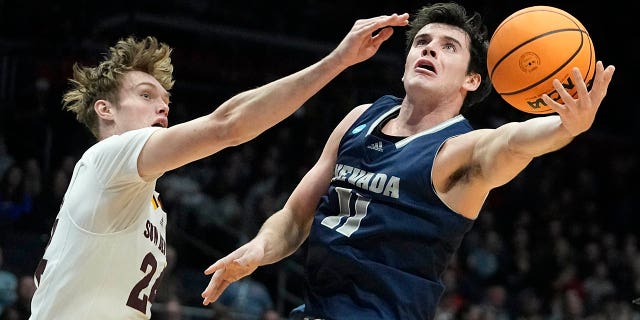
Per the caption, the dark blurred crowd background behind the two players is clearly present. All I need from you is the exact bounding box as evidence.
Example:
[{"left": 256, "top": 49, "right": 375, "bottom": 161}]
[{"left": 0, "top": 0, "right": 640, "bottom": 319}]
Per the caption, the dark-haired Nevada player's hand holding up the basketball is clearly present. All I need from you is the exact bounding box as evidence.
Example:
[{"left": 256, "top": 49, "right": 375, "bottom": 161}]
[{"left": 542, "top": 61, "right": 615, "bottom": 137}]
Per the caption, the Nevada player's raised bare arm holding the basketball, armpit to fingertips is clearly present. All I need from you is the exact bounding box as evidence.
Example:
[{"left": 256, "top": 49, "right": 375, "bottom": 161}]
[{"left": 432, "top": 62, "right": 615, "bottom": 218}]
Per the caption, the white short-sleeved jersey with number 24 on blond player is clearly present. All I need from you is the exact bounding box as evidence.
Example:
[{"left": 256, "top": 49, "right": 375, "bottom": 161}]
[{"left": 30, "top": 128, "right": 167, "bottom": 320}]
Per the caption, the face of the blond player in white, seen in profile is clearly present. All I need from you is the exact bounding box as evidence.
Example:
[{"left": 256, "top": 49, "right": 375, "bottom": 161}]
[{"left": 112, "top": 71, "right": 169, "bottom": 133}]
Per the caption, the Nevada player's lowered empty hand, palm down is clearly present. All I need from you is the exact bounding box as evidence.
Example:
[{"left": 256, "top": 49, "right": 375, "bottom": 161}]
[{"left": 201, "top": 239, "right": 264, "bottom": 306}]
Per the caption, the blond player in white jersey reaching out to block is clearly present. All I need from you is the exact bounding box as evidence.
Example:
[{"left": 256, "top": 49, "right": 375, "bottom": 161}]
[{"left": 31, "top": 14, "right": 408, "bottom": 320}]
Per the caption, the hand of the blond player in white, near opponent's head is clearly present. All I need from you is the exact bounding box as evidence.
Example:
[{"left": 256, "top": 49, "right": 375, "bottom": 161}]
[{"left": 332, "top": 13, "right": 409, "bottom": 67}]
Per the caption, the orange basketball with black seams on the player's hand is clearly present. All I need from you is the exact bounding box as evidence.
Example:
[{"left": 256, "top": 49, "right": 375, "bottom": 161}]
[{"left": 487, "top": 6, "right": 596, "bottom": 114}]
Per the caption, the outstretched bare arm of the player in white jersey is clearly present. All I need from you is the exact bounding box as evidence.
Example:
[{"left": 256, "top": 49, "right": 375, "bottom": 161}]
[{"left": 138, "top": 14, "right": 408, "bottom": 176}]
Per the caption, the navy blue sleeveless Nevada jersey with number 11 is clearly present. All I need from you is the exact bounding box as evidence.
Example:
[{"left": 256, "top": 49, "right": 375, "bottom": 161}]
[{"left": 304, "top": 96, "right": 473, "bottom": 320}]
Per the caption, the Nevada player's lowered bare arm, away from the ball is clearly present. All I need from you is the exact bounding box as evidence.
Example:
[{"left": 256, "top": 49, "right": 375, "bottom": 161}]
[{"left": 202, "top": 105, "right": 369, "bottom": 305}]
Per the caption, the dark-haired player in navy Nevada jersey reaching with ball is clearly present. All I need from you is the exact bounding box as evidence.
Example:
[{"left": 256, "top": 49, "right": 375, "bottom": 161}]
[{"left": 202, "top": 3, "right": 614, "bottom": 320}]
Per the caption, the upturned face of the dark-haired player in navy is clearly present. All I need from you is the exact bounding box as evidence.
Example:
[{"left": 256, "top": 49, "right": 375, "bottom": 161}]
[{"left": 403, "top": 23, "right": 470, "bottom": 99}]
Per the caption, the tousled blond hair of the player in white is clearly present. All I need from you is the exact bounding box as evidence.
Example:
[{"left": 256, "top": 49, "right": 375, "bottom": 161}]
[{"left": 62, "top": 37, "right": 174, "bottom": 138}]
